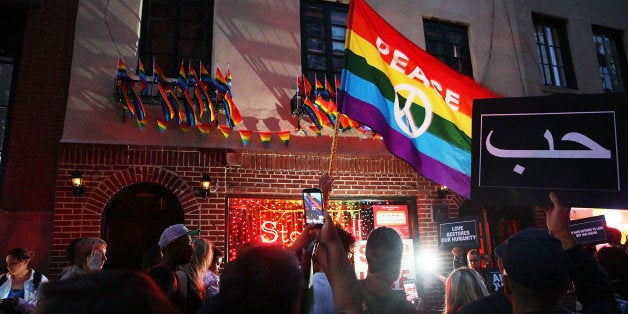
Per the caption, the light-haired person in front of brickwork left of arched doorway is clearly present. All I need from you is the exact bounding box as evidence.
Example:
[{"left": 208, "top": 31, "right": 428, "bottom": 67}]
[{"left": 61, "top": 238, "right": 107, "bottom": 280}]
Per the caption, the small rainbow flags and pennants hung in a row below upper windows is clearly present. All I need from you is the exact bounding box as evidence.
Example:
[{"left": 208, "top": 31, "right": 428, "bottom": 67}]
[{"left": 115, "top": 58, "right": 372, "bottom": 147}]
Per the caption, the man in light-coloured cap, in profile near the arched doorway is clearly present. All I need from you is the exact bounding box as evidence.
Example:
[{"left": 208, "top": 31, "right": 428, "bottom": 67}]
[{"left": 147, "top": 224, "right": 200, "bottom": 313}]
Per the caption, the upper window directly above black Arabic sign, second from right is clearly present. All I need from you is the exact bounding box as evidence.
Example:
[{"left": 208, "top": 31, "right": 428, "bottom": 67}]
[{"left": 532, "top": 15, "right": 576, "bottom": 88}]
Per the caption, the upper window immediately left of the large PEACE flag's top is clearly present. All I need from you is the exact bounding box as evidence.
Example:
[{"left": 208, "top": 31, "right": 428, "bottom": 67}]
[{"left": 301, "top": 1, "right": 349, "bottom": 89}]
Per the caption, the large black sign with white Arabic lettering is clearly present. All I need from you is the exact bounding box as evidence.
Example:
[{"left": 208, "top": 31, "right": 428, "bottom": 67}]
[{"left": 471, "top": 94, "right": 628, "bottom": 209}]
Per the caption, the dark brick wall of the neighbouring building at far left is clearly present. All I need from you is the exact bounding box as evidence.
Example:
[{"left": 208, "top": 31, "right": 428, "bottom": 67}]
[{"left": 2, "top": 0, "right": 78, "bottom": 212}]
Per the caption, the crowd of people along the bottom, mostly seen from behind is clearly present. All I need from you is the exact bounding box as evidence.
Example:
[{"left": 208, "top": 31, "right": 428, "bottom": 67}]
[{"left": 0, "top": 176, "right": 628, "bottom": 314}]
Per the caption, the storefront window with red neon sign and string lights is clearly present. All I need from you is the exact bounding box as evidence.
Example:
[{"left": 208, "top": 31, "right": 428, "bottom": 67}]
[{"left": 227, "top": 198, "right": 418, "bottom": 260}]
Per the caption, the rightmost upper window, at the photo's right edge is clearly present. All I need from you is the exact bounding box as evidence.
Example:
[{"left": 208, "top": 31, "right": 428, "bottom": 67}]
[{"left": 593, "top": 26, "right": 626, "bottom": 93}]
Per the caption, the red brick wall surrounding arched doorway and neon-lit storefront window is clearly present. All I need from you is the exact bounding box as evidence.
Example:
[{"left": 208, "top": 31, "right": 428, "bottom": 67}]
[{"left": 50, "top": 144, "right": 461, "bottom": 312}]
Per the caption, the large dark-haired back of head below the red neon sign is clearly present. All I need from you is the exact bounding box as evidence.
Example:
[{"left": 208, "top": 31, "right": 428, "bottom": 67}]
[{"left": 219, "top": 245, "right": 302, "bottom": 313}]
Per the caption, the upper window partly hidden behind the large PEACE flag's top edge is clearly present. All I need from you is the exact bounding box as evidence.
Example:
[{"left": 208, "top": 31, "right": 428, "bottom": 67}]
[{"left": 423, "top": 19, "right": 473, "bottom": 77}]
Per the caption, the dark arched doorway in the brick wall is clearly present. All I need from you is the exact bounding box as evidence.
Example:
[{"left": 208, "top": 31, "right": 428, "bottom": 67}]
[{"left": 101, "top": 183, "right": 183, "bottom": 270}]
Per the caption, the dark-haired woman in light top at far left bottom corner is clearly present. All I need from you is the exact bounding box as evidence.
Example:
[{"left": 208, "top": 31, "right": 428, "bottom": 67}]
[{"left": 0, "top": 247, "right": 48, "bottom": 314}]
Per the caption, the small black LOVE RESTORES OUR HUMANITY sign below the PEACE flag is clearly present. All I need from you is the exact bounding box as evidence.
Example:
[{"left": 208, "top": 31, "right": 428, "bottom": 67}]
[{"left": 438, "top": 218, "right": 479, "bottom": 247}]
